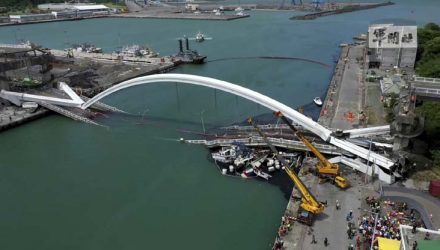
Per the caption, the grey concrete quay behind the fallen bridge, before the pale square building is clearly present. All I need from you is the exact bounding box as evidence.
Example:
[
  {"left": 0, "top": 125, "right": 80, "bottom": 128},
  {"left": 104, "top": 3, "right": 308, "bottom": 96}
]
[{"left": 318, "top": 45, "right": 386, "bottom": 130}]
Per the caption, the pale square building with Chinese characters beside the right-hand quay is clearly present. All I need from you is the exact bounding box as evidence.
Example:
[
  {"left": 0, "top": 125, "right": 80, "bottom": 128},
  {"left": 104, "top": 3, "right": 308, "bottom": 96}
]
[{"left": 367, "top": 24, "right": 417, "bottom": 69}]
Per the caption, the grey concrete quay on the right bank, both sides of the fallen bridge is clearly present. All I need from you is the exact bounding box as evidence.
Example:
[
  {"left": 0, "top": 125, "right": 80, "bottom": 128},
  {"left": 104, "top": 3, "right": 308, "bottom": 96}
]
[{"left": 281, "top": 42, "right": 383, "bottom": 250}]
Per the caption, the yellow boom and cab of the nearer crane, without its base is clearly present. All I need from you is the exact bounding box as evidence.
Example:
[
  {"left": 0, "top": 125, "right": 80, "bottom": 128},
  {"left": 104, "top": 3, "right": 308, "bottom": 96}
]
[{"left": 248, "top": 118, "right": 324, "bottom": 214}]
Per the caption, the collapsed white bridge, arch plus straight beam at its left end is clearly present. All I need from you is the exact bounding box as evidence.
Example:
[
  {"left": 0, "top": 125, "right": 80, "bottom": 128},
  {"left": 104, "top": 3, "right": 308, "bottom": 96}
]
[{"left": 1, "top": 74, "right": 394, "bottom": 183}]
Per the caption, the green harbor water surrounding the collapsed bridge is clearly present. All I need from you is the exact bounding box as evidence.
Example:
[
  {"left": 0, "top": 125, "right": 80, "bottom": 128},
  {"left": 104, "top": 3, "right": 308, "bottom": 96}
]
[{"left": 0, "top": 0, "right": 440, "bottom": 250}]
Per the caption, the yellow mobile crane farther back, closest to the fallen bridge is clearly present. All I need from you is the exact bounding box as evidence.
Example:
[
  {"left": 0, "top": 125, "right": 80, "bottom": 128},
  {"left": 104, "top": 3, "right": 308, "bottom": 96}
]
[{"left": 274, "top": 112, "right": 348, "bottom": 189}]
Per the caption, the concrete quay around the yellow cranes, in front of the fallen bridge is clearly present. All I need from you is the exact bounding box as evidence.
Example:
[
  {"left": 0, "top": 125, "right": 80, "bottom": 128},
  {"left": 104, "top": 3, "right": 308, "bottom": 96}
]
[{"left": 279, "top": 158, "right": 380, "bottom": 250}]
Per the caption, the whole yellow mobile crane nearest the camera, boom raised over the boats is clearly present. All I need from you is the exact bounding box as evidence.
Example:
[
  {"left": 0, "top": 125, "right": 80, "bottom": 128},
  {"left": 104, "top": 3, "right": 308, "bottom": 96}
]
[{"left": 248, "top": 118, "right": 324, "bottom": 225}]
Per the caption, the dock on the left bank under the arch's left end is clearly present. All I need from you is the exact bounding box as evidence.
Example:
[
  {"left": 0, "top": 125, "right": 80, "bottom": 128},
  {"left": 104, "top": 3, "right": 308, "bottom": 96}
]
[{"left": 0, "top": 44, "right": 181, "bottom": 131}]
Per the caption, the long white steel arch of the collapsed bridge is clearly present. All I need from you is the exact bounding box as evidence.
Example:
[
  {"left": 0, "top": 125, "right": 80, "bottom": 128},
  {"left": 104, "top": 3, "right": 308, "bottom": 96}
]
[{"left": 81, "top": 74, "right": 394, "bottom": 173}]
